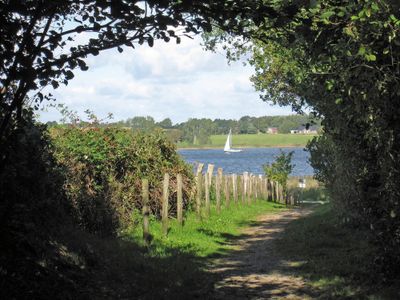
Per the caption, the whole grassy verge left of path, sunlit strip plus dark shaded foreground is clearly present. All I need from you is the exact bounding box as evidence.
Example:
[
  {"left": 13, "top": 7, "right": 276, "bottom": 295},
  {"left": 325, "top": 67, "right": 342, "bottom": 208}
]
[{"left": 59, "top": 198, "right": 284, "bottom": 299}]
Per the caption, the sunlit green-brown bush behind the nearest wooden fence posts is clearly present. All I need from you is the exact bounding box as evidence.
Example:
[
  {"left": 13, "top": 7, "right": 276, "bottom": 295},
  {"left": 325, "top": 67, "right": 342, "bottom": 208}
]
[{"left": 51, "top": 127, "right": 193, "bottom": 234}]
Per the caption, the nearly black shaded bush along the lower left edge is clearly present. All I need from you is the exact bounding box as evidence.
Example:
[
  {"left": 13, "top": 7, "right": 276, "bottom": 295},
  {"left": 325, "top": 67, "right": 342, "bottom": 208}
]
[{"left": 0, "top": 111, "right": 73, "bottom": 299}]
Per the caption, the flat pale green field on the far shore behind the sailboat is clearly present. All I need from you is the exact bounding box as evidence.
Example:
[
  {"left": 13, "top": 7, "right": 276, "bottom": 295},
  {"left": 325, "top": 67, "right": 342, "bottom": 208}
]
[{"left": 178, "top": 134, "right": 315, "bottom": 148}]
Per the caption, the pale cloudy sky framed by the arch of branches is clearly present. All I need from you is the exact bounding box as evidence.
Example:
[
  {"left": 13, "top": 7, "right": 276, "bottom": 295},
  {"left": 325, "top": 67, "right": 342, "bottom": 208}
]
[{"left": 39, "top": 38, "right": 292, "bottom": 123}]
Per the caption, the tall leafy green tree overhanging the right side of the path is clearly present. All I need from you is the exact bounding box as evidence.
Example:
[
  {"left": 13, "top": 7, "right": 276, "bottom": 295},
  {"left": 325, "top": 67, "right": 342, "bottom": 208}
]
[{"left": 209, "top": 0, "right": 400, "bottom": 276}]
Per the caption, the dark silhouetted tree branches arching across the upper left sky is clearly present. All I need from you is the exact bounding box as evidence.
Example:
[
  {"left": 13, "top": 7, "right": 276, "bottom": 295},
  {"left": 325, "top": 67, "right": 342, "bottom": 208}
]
[{"left": 0, "top": 0, "right": 270, "bottom": 157}]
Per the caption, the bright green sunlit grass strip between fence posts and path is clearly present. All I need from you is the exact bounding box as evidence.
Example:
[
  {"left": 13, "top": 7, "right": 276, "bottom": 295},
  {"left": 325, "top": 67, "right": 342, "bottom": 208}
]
[{"left": 125, "top": 201, "right": 283, "bottom": 257}]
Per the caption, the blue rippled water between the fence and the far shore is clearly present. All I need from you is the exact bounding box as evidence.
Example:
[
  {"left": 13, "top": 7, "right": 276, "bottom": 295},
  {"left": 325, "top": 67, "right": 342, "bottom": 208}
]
[{"left": 178, "top": 148, "right": 314, "bottom": 176}]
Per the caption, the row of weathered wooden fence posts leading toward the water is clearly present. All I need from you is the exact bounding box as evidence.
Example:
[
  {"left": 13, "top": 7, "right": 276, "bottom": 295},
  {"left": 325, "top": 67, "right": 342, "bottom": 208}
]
[{"left": 142, "top": 163, "right": 296, "bottom": 242}]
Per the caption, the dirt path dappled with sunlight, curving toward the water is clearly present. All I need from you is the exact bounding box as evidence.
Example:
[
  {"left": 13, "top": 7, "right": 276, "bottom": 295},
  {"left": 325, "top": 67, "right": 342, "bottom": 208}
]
[{"left": 210, "top": 208, "right": 312, "bottom": 299}]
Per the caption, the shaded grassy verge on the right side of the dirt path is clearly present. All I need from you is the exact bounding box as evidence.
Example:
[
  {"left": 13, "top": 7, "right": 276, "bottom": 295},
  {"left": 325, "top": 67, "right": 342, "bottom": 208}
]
[{"left": 278, "top": 204, "right": 400, "bottom": 299}]
